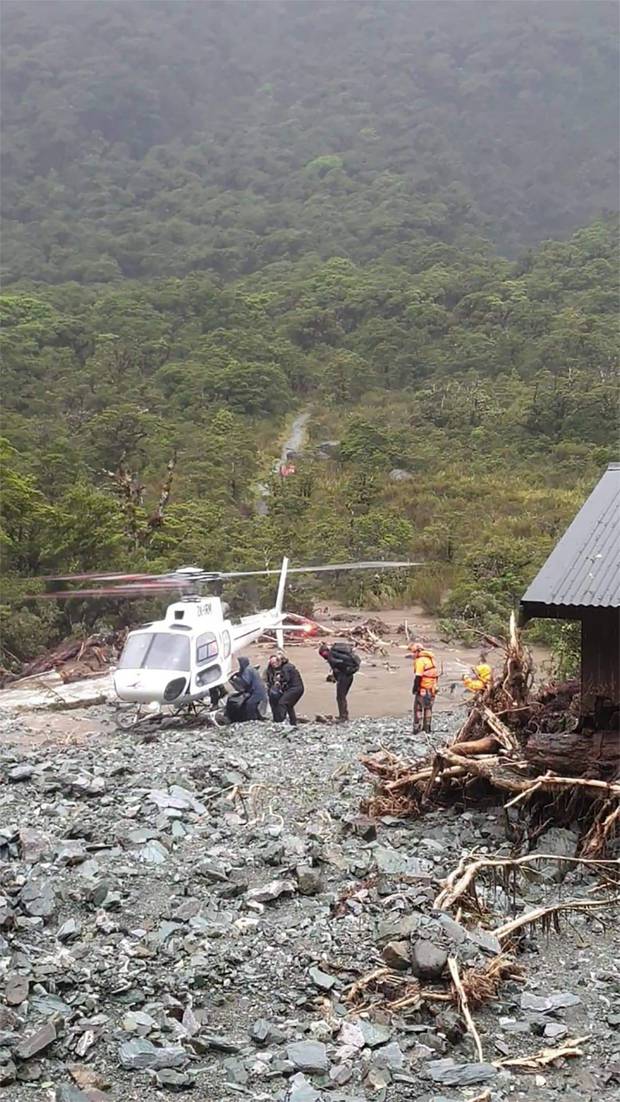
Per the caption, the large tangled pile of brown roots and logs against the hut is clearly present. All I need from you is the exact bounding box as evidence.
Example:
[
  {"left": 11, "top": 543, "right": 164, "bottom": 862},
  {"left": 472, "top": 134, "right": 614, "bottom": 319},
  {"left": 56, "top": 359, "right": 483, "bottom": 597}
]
[{"left": 362, "top": 625, "right": 620, "bottom": 858}]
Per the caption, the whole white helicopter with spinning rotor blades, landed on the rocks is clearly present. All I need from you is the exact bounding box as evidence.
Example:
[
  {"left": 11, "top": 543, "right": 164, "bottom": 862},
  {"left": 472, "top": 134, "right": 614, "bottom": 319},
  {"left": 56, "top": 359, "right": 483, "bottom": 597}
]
[{"left": 36, "top": 558, "right": 421, "bottom": 730}]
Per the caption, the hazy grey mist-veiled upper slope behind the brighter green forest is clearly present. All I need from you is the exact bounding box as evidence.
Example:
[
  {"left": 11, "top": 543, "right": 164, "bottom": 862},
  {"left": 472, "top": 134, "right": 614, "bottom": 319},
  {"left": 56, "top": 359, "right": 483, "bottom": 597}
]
[{"left": 2, "top": 0, "right": 618, "bottom": 282}]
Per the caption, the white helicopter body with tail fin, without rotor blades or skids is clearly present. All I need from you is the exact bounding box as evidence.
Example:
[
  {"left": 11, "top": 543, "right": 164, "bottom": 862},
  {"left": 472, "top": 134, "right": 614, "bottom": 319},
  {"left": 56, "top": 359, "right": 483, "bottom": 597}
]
[{"left": 113, "top": 560, "right": 287, "bottom": 707}]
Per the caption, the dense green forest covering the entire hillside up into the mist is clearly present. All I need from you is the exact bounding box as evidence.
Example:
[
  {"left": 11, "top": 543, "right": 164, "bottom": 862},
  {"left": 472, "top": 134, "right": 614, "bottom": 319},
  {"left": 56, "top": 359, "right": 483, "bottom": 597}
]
[{"left": 0, "top": 0, "right": 618, "bottom": 666}]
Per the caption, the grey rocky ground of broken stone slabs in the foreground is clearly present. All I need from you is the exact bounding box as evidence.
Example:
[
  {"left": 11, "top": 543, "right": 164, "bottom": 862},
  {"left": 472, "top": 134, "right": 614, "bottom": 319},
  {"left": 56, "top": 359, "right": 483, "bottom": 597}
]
[{"left": 0, "top": 709, "right": 620, "bottom": 1102}]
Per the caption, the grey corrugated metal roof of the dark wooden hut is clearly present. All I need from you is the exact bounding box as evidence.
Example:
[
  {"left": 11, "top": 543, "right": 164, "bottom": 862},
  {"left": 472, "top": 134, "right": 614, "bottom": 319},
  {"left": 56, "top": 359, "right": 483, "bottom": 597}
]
[{"left": 521, "top": 463, "right": 620, "bottom": 612}]
